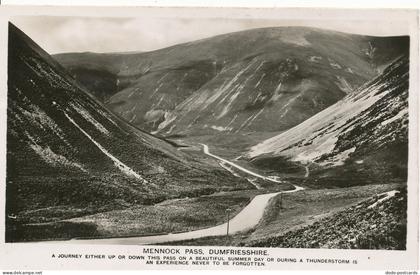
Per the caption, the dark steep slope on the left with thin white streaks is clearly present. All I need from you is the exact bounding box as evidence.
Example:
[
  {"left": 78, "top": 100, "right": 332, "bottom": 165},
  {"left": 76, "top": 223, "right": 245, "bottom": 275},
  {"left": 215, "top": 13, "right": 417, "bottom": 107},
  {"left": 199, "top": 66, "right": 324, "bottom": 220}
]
[{"left": 6, "top": 24, "right": 252, "bottom": 239}]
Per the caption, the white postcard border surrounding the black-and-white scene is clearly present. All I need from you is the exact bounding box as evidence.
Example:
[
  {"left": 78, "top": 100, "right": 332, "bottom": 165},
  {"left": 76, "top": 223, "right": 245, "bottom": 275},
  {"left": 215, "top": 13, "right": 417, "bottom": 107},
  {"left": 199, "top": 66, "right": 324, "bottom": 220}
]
[{"left": 0, "top": 1, "right": 419, "bottom": 270}]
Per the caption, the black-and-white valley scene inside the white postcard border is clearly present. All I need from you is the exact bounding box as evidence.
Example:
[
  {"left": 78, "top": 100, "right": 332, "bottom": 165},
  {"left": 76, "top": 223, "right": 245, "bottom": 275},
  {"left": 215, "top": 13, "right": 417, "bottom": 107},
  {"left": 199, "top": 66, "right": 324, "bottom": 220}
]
[{"left": 0, "top": 3, "right": 418, "bottom": 272}]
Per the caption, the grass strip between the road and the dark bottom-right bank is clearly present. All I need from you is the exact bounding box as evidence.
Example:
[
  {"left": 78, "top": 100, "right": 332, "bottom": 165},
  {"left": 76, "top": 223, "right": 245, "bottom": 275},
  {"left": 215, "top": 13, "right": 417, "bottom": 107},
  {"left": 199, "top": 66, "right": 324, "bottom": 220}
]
[{"left": 162, "top": 184, "right": 401, "bottom": 246}]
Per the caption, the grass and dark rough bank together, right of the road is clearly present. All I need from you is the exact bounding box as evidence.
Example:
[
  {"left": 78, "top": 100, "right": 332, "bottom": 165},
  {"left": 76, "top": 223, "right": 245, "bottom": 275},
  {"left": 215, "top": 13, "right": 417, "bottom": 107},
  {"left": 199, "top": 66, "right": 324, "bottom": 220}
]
[{"left": 162, "top": 183, "right": 406, "bottom": 249}]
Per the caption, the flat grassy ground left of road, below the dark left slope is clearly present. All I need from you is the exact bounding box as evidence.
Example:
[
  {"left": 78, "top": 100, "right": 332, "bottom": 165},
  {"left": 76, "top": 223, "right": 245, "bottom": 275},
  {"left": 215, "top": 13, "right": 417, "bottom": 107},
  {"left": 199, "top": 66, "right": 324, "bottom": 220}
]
[{"left": 9, "top": 190, "right": 276, "bottom": 241}]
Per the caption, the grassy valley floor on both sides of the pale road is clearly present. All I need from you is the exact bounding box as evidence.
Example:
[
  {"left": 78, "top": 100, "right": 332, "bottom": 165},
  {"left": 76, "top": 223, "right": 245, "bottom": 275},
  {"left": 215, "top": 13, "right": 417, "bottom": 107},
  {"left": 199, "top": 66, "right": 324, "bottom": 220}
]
[{"left": 11, "top": 142, "right": 402, "bottom": 246}]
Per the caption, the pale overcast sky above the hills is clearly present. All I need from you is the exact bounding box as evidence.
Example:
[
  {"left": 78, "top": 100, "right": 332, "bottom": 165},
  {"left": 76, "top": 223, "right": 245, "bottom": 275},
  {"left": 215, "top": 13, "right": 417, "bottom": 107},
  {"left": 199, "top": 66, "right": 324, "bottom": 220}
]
[{"left": 11, "top": 16, "right": 410, "bottom": 54}]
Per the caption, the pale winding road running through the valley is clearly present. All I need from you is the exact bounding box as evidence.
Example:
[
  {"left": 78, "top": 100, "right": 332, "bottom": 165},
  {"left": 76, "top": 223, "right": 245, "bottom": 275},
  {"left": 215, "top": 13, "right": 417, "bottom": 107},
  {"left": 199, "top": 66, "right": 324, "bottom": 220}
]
[{"left": 50, "top": 144, "right": 304, "bottom": 245}]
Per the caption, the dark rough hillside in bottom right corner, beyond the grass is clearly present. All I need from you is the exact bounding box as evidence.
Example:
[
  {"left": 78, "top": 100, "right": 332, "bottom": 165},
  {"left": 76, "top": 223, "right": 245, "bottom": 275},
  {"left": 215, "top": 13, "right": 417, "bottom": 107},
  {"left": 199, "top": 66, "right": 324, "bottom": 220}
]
[{"left": 247, "top": 189, "right": 407, "bottom": 250}]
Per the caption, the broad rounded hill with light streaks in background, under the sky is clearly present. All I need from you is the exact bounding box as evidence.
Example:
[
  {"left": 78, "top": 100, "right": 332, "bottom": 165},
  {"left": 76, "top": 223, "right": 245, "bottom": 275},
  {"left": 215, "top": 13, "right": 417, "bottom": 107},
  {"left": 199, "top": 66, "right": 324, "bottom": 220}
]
[{"left": 55, "top": 27, "right": 408, "bottom": 135}]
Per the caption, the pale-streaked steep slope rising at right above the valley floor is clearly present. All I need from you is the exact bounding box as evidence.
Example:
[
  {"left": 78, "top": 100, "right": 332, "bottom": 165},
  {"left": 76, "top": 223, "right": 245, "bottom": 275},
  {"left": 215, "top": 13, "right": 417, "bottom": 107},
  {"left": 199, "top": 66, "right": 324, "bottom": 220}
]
[{"left": 247, "top": 56, "right": 409, "bottom": 188}]
